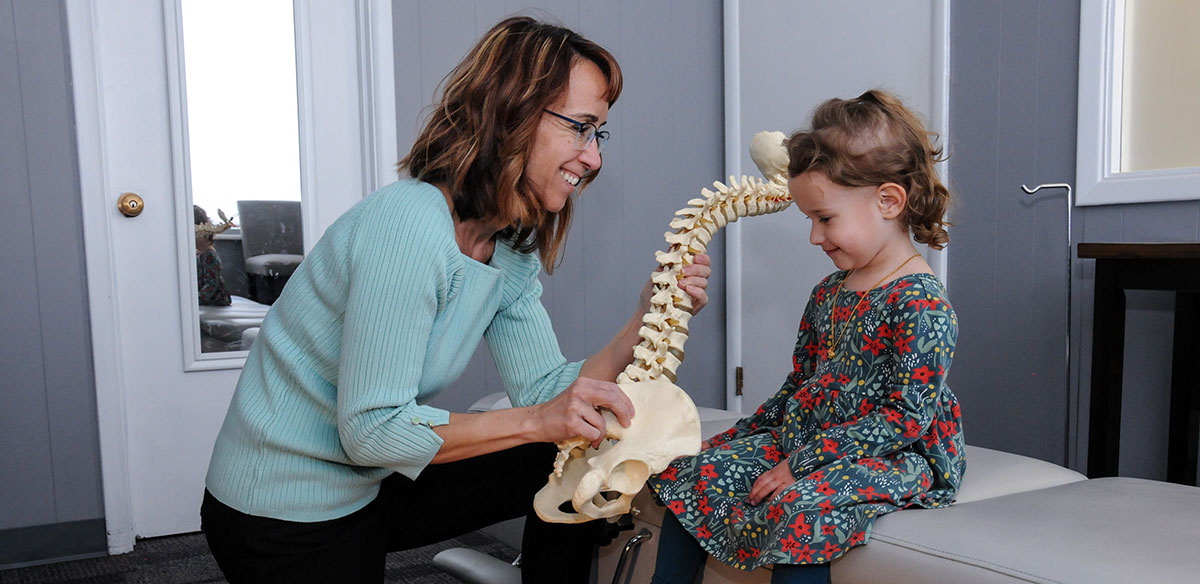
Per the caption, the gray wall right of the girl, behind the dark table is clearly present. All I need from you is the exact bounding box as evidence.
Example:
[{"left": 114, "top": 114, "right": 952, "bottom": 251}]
[{"left": 947, "top": 0, "right": 1200, "bottom": 478}]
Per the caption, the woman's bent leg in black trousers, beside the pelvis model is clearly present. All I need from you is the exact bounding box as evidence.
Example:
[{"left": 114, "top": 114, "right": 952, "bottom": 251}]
[{"left": 379, "top": 444, "right": 604, "bottom": 583}]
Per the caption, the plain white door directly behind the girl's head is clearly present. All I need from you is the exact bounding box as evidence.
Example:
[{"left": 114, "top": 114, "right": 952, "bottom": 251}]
[{"left": 725, "top": 0, "right": 949, "bottom": 413}]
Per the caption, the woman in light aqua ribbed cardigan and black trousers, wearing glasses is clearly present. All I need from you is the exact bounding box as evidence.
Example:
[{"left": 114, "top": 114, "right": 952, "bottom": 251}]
[{"left": 202, "top": 17, "right": 710, "bottom": 583}]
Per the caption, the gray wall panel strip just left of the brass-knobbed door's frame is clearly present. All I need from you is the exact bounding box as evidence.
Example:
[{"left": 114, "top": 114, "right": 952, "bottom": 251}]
[{"left": 14, "top": 1, "right": 103, "bottom": 522}]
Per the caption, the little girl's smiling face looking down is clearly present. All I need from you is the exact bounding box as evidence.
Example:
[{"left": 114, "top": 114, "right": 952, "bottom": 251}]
[{"left": 787, "top": 170, "right": 898, "bottom": 270}]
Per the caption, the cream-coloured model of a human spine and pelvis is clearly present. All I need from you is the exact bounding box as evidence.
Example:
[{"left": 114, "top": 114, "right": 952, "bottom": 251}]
[{"left": 534, "top": 132, "right": 792, "bottom": 523}]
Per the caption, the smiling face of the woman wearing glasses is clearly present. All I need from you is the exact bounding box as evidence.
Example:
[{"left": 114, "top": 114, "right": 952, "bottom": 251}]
[{"left": 524, "top": 59, "right": 608, "bottom": 212}]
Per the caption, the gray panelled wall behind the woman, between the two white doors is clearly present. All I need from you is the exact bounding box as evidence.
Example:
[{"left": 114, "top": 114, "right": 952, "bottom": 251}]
[{"left": 392, "top": 0, "right": 725, "bottom": 411}]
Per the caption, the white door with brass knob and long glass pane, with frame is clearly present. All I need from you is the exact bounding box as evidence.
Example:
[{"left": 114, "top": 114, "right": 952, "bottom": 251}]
[{"left": 67, "top": 0, "right": 396, "bottom": 553}]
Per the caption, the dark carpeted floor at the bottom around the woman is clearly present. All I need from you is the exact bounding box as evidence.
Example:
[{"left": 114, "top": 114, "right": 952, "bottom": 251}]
[{"left": 0, "top": 531, "right": 517, "bottom": 584}]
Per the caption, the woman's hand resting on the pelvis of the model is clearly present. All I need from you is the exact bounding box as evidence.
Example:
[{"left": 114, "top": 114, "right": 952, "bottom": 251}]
[{"left": 533, "top": 378, "right": 635, "bottom": 448}]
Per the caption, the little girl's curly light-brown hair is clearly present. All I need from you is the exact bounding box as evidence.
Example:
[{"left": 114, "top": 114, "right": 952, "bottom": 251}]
[{"left": 787, "top": 90, "right": 950, "bottom": 249}]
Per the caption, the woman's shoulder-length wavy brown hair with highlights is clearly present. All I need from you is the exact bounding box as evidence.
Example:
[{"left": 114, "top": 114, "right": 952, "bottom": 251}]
[{"left": 397, "top": 17, "right": 622, "bottom": 272}]
